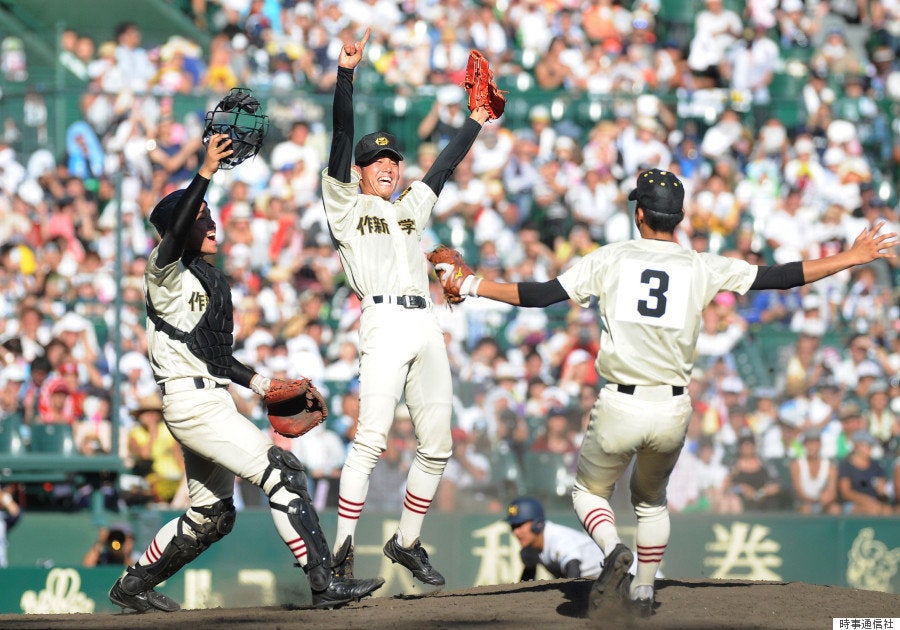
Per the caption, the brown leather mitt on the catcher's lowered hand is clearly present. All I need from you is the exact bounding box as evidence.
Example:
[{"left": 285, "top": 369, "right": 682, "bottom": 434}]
[{"left": 263, "top": 378, "right": 328, "bottom": 437}]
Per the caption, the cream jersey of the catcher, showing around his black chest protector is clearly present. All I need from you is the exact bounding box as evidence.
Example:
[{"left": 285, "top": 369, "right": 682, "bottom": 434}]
[{"left": 144, "top": 245, "right": 230, "bottom": 384}]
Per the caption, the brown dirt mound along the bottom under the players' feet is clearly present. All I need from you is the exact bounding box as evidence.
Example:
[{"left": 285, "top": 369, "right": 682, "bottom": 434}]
[{"left": 0, "top": 579, "right": 900, "bottom": 630}]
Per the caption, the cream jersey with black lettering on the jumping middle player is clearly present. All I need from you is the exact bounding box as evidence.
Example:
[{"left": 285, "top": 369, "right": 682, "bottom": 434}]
[{"left": 322, "top": 169, "right": 437, "bottom": 298}]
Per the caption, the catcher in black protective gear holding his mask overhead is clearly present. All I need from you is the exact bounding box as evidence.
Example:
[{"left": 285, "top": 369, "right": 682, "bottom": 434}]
[{"left": 109, "top": 91, "right": 384, "bottom": 612}]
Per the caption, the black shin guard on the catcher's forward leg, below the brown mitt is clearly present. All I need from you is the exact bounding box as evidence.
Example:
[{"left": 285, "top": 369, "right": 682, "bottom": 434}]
[{"left": 261, "top": 446, "right": 332, "bottom": 591}]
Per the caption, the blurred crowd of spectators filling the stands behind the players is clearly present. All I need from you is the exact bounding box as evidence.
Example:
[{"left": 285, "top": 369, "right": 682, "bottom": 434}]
[{"left": 0, "top": 0, "right": 900, "bottom": 514}]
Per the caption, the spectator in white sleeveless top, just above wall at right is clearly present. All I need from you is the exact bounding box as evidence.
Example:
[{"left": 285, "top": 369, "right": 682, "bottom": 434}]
[{"left": 790, "top": 429, "right": 841, "bottom": 515}]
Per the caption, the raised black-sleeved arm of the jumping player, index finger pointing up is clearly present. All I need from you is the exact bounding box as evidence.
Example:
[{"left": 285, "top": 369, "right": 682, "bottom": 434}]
[{"left": 328, "top": 29, "right": 369, "bottom": 183}]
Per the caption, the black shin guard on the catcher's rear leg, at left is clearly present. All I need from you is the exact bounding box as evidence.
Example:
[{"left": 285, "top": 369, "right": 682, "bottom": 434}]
[{"left": 128, "top": 499, "right": 236, "bottom": 588}]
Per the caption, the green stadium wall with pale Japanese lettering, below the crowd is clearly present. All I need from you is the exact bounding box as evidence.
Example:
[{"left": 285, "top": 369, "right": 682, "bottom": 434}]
[{"left": 0, "top": 508, "right": 900, "bottom": 614}]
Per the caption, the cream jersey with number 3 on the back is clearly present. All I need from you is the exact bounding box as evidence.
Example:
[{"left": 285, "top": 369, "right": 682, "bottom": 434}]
[{"left": 559, "top": 239, "right": 757, "bottom": 386}]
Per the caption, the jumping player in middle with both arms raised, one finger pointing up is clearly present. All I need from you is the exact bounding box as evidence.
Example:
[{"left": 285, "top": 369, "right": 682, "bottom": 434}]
[{"left": 322, "top": 30, "right": 492, "bottom": 586}]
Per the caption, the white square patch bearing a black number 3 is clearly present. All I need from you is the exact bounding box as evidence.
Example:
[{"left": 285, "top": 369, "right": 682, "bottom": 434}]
[{"left": 612, "top": 258, "right": 691, "bottom": 330}]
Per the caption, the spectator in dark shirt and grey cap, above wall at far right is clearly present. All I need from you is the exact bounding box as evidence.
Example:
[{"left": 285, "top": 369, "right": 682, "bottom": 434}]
[{"left": 838, "top": 431, "right": 893, "bottom": 515}]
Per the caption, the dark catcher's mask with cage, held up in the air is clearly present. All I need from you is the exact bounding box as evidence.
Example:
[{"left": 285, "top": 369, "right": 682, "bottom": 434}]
[{"left": 203, "top": 88, "right": 269, "bottom": 169}]
